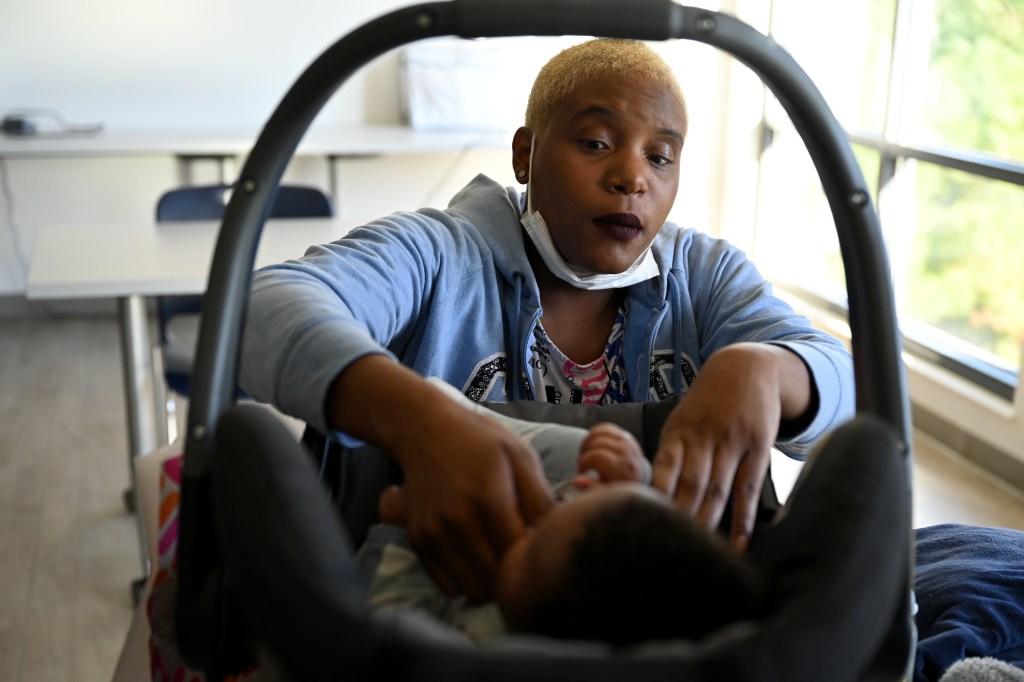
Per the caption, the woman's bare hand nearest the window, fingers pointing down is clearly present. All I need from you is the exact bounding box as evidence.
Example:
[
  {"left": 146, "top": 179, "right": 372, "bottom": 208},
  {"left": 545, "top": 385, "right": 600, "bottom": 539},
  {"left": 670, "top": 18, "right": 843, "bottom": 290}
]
[{"left": 652, "top": 343, "right": 811, "bottom": 551}]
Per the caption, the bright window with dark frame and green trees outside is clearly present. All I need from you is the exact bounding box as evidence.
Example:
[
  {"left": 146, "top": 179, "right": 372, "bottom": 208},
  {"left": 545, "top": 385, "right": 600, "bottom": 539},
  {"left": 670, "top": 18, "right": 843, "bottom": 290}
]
[{"left": 754, "top": 0, "right": 1024, "bottom": 398}]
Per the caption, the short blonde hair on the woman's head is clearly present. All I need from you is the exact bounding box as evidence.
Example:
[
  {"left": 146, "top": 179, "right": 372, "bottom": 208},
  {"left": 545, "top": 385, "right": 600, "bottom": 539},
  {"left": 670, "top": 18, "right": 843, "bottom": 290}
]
[{"left": 526, "top": 38, "right": 689, "bottom": 137}]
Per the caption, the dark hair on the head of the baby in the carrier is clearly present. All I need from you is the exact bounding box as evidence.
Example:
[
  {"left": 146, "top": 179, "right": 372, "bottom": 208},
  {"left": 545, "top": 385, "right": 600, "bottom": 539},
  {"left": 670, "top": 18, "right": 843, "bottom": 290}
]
[{"left": 517, "top": 496, "right": 766, "bottom": 646}]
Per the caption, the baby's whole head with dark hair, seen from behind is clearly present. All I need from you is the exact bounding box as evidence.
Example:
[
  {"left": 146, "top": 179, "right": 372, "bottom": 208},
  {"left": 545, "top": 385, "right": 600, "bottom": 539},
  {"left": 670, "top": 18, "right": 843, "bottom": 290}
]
[{"left": 497, "top": 483, "right": 764, "bottom": 645}]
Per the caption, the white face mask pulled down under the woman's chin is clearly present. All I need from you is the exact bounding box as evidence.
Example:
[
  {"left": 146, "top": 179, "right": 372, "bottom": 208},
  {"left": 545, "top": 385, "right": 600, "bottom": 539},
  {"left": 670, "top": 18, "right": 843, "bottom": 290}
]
[{"left": 520, "top": 137, "right": 660, "bottom": 290}]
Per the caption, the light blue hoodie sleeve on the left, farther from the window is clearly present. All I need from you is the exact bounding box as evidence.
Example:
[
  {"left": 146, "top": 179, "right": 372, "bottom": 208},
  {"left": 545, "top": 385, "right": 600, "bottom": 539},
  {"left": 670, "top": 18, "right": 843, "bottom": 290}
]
[{"left": 240, "top": 212, "right": 455, "bottom": 433}]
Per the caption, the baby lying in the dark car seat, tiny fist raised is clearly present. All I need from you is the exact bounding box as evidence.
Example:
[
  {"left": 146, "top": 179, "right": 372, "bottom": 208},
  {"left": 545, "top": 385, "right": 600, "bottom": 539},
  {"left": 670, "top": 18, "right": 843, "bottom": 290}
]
[{"left": 358, "top": 382, "right": 764, "bottom": 645}]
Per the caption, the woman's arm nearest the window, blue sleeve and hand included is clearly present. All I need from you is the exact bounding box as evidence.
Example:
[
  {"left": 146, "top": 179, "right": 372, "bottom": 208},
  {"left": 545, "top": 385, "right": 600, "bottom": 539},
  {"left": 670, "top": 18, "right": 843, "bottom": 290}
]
[{"left": 653, "top": 231, "right": 854, "bottom": 548}]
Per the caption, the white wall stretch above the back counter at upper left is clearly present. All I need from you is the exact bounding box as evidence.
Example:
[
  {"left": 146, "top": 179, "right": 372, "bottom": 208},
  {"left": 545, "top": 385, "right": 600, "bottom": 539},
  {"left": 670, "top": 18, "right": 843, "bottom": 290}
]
[{"left": 0, "top": 0, "right": 409, "bottom": 129}]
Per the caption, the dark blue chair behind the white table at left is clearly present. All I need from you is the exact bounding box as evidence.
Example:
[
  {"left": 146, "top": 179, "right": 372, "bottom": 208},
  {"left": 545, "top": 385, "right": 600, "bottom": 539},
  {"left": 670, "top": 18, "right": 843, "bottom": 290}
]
[{"left": 157, "top": 184, "right": 334, "bottom": 397}]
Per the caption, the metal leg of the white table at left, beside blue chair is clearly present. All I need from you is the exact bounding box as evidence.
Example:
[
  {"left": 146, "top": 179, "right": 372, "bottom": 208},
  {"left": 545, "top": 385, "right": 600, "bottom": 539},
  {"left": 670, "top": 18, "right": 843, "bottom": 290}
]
[{"left": 118, "top": 296, "right": 158, "bottom": 577}]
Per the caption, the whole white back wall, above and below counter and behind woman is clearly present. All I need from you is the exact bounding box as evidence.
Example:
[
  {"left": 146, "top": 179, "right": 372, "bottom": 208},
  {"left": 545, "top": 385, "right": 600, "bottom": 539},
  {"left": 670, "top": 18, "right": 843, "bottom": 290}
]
[{"left": 0, "top": 0, "right": 723, "bottom": 296}]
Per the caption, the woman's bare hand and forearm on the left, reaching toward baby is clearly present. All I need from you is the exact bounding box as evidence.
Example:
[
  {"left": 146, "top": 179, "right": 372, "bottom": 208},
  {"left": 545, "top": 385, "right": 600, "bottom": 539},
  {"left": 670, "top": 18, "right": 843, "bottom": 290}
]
[{"left": 329, "top": 355, "right": 554, "bottom": 600}]
